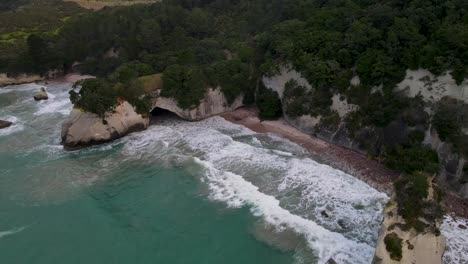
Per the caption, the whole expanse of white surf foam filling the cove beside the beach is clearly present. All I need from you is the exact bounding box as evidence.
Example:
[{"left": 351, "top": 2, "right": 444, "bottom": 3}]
[{"left": 122, "top": 117, "right": 388, "bottom": 263}]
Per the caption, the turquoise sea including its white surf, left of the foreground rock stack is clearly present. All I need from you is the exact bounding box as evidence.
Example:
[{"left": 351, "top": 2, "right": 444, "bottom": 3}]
[{"left": 0, "top": 83, "right": 388, "bottom": 263}]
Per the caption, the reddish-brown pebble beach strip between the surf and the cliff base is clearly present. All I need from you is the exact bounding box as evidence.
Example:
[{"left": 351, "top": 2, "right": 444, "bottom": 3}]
[{"left": 221, "top": 107, "right": 468, "bottom": 219}]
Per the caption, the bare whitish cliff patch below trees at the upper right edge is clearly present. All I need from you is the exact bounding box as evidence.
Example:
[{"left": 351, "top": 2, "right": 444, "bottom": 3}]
[{"left": 397, "top": 69, "right": 468, "bottom": 103}]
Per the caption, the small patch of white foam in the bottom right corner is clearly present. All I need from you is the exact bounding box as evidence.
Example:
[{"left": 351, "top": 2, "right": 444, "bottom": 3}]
[{"left": 441, "top": 216, "right": 468, "bottom": 264}]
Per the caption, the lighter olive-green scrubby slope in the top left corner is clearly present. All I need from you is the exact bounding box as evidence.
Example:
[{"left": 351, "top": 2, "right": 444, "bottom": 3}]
[{"left": 0, "top": 0, "right": 87, "bottom": 74}]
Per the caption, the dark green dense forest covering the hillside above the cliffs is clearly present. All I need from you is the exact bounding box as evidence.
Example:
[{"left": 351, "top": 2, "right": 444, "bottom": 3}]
[{"left": 2, "top": 0, "right": 468, "bottom": 104}]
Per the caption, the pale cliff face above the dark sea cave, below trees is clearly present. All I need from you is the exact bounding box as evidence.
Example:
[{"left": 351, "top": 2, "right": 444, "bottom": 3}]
[{"left": 153, "top": 88, "right": 243, "bottom": 121}]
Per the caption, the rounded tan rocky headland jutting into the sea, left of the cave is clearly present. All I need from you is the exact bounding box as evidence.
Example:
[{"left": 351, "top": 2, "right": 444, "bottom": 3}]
[{"left": 62, "top": 101, "right": 149, "bottom": 149}]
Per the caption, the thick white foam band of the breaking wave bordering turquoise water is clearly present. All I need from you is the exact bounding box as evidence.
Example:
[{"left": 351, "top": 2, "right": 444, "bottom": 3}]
[{"left": 194, "top": 158, "right": 374, "bottom": 263}]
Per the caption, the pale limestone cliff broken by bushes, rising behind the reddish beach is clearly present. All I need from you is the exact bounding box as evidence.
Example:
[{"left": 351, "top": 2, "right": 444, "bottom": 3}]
[{"left": 263, "top": 65, "right": 468, "bottom": 199}]
